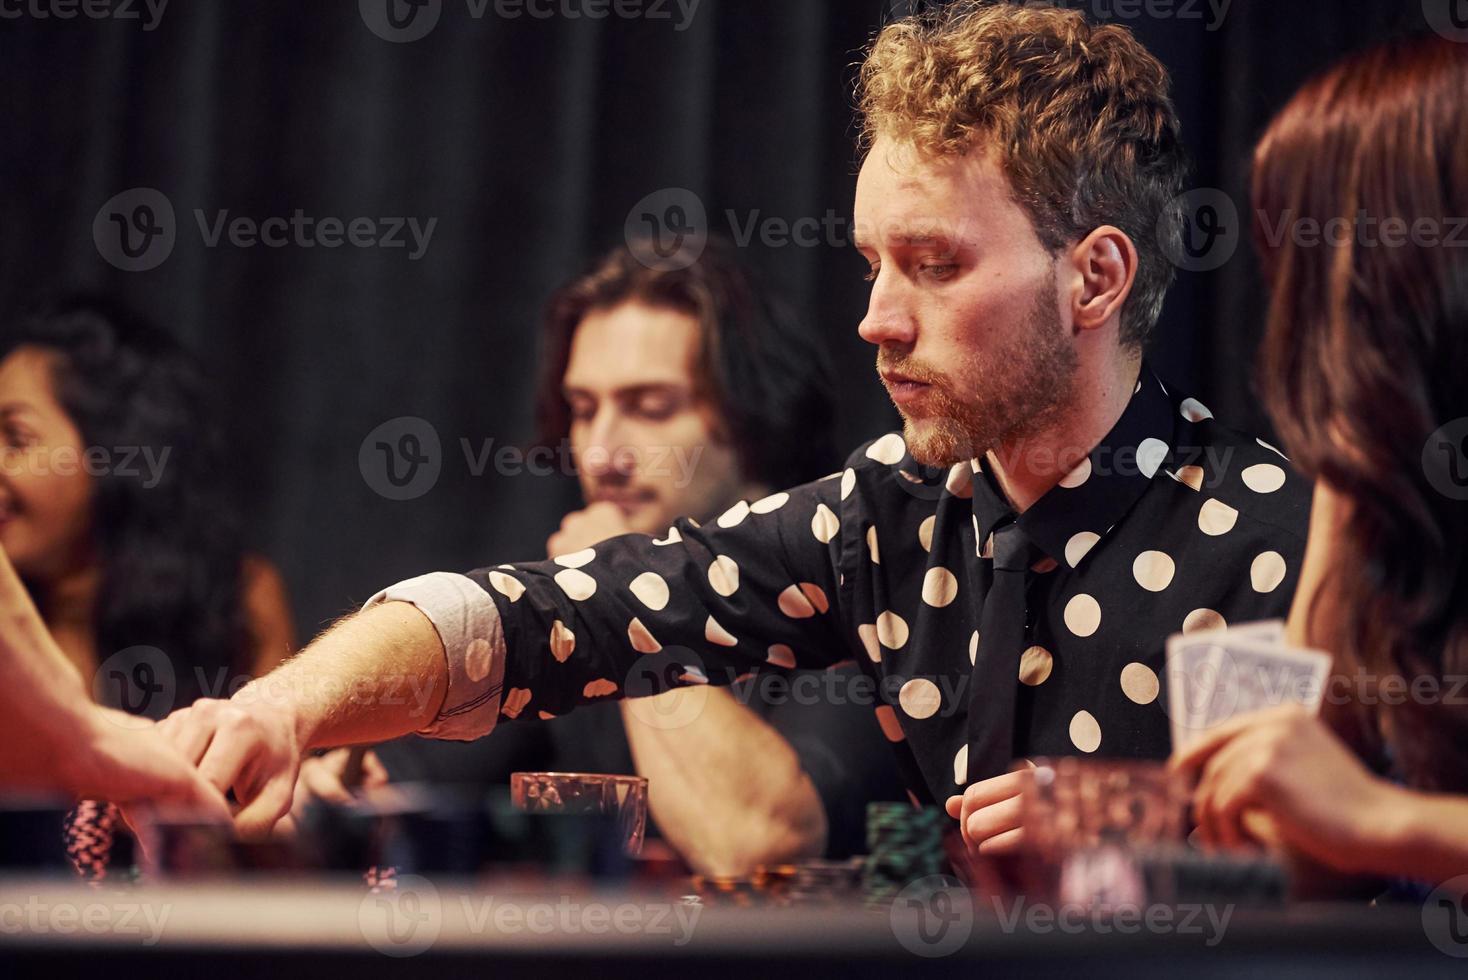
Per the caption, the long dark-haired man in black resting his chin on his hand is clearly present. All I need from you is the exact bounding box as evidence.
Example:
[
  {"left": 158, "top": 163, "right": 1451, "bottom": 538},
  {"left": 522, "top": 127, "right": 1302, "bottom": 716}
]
[{"left": 380, "top": 241, "right": 901, "bottom": 874}]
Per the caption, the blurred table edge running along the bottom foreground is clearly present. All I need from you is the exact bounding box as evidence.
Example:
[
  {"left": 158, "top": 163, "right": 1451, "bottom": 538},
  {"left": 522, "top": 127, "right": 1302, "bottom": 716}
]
[{"left": 0, "top": 879, "right": 1468, "bottom": 980}]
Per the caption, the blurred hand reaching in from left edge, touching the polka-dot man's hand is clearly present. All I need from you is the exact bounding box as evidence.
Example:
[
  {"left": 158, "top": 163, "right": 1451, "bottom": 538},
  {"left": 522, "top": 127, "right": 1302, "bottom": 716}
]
[{"left": 62, "top": 707, "right": 229, "bottom": 822}]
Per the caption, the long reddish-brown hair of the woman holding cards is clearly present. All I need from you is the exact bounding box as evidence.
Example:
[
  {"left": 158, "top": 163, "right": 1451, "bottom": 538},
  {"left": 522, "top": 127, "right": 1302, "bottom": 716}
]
[{"left": 1254, "top": 35, "right": 1468, "bottom": 789}]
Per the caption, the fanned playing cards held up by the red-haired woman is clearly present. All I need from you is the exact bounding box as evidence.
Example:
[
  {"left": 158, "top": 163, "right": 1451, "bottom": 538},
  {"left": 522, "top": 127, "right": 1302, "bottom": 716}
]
[{"left": 1167, "top": 624, "right": 1331, "bottom": 750}]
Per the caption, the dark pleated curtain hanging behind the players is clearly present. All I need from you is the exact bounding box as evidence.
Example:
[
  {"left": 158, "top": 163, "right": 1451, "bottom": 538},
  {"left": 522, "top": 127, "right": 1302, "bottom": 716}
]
[{"left": 0, "top": 0, "right": 1431, "bottom": 635}]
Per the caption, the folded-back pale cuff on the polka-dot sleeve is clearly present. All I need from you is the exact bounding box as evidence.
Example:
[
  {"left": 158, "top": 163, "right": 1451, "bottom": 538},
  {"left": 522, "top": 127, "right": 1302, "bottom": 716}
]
[{"left": 363, "top": 572, "right": 505, "bottom": 742}]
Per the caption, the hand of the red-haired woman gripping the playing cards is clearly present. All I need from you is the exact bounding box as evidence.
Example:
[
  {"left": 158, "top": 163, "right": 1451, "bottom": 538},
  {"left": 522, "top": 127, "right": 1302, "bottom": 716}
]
[{"left": 1171, "top": 706, "right": 1402, "bottom": 873}]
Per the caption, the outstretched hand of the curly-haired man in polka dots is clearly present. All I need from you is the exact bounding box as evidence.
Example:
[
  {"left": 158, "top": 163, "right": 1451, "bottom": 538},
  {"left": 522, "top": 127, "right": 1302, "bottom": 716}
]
[{"left": 159, "top": 688, "right": 301, "bottom": 838}]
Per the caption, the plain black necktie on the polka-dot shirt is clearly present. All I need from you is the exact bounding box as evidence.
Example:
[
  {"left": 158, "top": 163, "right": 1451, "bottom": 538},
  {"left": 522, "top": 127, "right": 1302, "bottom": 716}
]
[{"left": 969, "top": 519, "right": 1035, "bottom": 783}]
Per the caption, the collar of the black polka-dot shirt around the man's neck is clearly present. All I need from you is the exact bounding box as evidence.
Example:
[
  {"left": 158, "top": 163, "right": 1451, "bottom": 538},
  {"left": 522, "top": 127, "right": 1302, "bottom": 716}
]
[{"left": 970, "top": 362, "right": 1173, "bottom": 568}]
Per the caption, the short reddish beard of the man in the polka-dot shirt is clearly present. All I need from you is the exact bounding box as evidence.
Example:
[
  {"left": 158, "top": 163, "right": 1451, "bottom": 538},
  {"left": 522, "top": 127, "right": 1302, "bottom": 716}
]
[{"left": 878, "top": 277, "right": 1079, "bottom": 467}]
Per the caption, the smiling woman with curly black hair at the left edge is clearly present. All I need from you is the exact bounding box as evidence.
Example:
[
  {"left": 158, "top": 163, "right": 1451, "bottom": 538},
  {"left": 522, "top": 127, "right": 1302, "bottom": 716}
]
[{"left": 0, "top": 301, "right": 294, "bottom": 695}]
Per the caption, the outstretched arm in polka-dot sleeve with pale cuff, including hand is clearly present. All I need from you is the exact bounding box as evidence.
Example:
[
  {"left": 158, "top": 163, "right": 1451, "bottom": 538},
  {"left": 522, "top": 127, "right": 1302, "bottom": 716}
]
[{"left": 164, "top": 480, "right": 850, "bottom": 833}]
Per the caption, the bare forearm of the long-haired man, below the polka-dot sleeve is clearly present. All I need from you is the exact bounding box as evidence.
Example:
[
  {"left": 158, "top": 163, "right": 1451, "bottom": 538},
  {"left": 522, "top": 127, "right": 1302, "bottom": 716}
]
[{"left": 622, "top": 688, "right": 826, "bottom": 874}]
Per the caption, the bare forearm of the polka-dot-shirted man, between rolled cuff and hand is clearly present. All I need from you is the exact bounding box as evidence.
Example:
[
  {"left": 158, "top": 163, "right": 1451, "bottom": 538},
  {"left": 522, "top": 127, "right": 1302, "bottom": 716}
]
[{"left": 233, "top": 601, "right": 448, "bottom": 751}]
